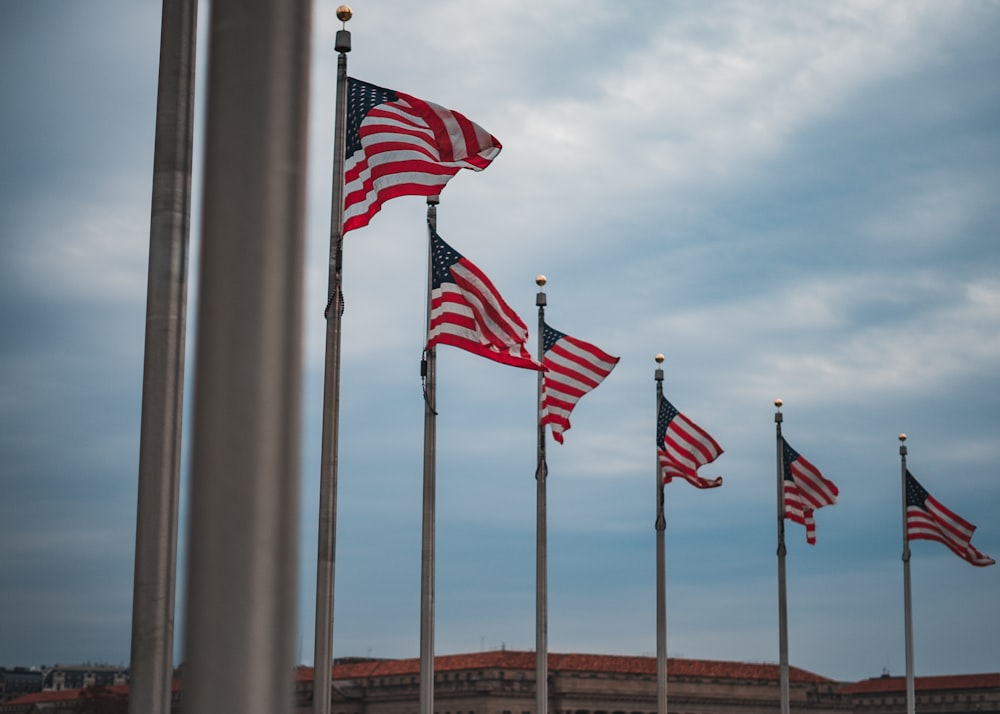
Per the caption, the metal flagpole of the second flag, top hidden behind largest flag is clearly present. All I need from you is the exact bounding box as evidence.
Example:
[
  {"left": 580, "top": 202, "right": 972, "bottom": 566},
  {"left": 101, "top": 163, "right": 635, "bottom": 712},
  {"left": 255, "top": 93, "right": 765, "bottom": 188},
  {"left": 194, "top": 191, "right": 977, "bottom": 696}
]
[{"left": 420, "top": 196, "right": 440, "bottom": 714}]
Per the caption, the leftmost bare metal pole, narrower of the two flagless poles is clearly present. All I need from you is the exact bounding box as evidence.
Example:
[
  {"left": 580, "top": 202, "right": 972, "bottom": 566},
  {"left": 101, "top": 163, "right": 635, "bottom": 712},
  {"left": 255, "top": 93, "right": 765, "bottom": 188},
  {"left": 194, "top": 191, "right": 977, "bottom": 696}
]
[{"left": 129, "top": 0, "right": 198, "bottom": 714}]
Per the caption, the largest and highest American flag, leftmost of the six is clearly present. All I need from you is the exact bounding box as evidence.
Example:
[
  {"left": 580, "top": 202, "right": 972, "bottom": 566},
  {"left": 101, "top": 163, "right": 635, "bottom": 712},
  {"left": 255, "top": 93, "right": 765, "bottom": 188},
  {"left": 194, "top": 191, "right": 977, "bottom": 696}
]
[{"left": 344, "top": 77, "right": 501, "bottom": 233}]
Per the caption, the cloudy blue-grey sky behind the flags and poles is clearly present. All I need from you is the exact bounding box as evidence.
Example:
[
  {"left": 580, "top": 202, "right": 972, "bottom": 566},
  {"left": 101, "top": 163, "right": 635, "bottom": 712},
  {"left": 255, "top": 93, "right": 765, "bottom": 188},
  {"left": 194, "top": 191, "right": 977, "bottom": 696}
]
[{"left": 0, "top": 0, "right": 1000, "bottom": 681}]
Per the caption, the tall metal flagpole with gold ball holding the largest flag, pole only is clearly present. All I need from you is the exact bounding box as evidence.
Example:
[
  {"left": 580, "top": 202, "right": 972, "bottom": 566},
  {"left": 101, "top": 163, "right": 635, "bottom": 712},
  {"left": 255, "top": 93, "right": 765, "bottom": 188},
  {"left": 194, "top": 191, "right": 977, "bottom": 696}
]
[{"left": 313, "top": 5, "right": 352, "bottom": 714}]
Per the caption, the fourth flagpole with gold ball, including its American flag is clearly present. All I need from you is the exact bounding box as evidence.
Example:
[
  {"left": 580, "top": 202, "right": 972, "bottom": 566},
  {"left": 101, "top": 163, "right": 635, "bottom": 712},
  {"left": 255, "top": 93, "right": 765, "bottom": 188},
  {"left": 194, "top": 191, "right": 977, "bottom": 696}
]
[{"left": 654, "top": 354, "right": 722, "bottom": 714}]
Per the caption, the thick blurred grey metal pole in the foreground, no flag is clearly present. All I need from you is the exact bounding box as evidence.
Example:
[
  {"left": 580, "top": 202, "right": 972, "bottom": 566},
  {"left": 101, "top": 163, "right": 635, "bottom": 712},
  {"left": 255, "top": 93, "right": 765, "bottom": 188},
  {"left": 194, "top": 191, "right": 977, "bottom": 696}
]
[{"left": 184, "top": 0, "right": 312, "bottom": 714}]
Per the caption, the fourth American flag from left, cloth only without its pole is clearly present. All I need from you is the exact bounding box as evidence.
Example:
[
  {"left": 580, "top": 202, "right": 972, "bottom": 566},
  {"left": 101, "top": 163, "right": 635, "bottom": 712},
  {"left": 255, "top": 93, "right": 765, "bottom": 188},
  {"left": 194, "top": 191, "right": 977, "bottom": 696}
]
[{"left": 656, "top": 395, "right": 722, "bottom": 488}]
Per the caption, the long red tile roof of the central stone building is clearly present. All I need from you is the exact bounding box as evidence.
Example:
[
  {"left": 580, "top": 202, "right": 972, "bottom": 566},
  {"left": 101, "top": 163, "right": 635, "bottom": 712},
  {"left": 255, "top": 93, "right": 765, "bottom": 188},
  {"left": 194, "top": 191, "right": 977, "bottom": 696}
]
[{"left": 296, "top": 650, "right": 834, "bottom": 683}]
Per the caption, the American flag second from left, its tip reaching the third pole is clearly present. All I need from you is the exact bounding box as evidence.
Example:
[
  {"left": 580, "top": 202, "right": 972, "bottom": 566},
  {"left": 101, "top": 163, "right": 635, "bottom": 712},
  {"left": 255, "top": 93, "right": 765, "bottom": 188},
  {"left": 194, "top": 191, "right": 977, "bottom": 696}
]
[{"left": 427, "top": 231, "right": 543, "bottom": 370}]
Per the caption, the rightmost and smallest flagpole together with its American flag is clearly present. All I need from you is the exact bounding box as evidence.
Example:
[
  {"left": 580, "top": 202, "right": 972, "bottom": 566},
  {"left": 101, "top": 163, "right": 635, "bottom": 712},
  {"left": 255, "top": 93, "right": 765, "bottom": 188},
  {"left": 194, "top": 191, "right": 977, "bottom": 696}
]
[{"left": 899, "top": 434, "right": 996, "bottom": 714}]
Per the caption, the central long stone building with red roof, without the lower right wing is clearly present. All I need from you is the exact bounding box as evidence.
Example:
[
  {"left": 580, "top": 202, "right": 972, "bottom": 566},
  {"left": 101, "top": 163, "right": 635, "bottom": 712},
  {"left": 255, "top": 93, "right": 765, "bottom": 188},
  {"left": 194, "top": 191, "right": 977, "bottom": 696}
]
[{"left": 296, "top": 650, "right": 851, "bottom": 714}]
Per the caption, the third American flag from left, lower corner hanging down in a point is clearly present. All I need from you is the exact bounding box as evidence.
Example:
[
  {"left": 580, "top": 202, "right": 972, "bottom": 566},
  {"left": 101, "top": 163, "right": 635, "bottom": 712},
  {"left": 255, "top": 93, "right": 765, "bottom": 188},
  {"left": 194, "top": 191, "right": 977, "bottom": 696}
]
[{"left": 542, "top": 324, "right": 619, "bottom": 444}]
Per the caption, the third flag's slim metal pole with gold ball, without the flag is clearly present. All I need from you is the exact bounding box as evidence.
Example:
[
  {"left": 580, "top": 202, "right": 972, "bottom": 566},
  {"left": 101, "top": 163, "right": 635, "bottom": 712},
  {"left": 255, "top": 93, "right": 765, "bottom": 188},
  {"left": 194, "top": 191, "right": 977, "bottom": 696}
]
[{"left": 535, "top": 275, "right": 549, "bottom": 714}]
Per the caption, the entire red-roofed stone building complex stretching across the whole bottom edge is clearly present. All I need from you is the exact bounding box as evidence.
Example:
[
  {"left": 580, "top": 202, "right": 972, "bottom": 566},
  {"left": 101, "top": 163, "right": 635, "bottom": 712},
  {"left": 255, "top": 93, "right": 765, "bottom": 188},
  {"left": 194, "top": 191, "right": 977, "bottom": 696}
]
[{"left": 0, "top": 650, "right": 1000, "bottom": 714}]
